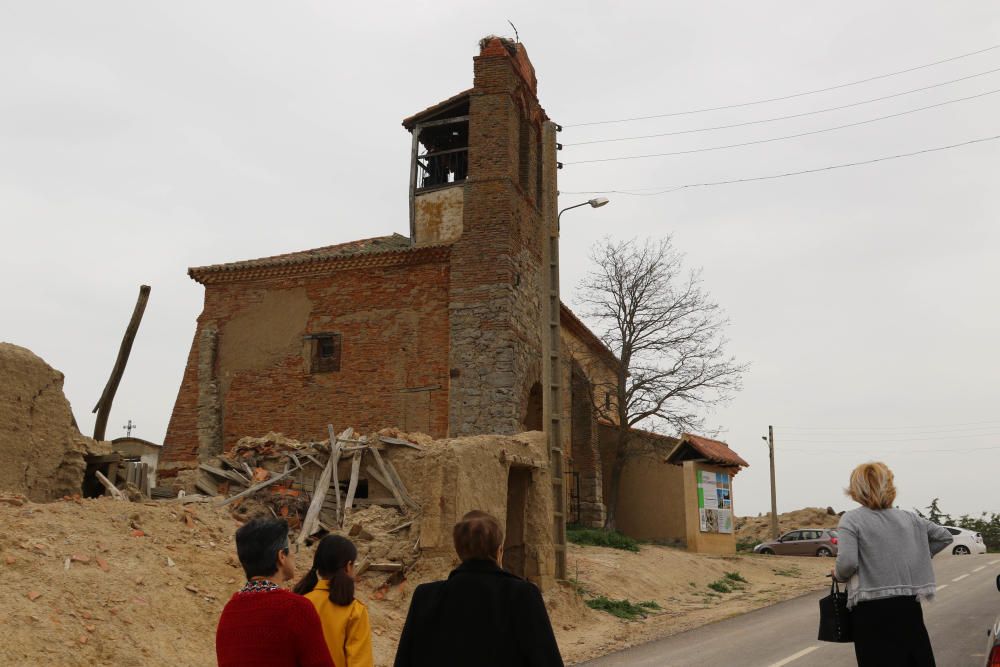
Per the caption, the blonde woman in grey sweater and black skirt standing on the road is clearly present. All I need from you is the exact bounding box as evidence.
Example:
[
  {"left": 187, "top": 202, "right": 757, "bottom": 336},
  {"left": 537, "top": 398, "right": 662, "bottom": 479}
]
[{"left": 833, "top": 463, "right": 952, "bottom": 667}]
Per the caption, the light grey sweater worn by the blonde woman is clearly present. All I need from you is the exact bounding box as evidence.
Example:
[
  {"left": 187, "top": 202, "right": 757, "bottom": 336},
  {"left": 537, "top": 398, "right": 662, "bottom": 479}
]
[{"left": 836, "top": 507, "right": 952, "bottom": 608}]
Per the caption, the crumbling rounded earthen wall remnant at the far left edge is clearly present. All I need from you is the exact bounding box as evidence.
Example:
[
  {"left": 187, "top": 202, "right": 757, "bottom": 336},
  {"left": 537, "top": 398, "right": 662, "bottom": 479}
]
[{"left": 0, "top": 343, "right": 111, "bottom": 502}]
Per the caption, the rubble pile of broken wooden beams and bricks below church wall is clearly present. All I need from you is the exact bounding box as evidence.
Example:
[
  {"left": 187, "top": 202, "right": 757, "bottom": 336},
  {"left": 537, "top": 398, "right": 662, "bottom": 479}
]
[{"left": 194, "top": 428, "right": 423, "bottom": 580}]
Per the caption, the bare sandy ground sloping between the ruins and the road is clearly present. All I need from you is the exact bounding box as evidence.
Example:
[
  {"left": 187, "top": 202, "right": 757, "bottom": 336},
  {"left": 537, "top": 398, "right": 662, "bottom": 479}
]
[{"left": 0, "top": 494, "right": 831, "bottom": 666}]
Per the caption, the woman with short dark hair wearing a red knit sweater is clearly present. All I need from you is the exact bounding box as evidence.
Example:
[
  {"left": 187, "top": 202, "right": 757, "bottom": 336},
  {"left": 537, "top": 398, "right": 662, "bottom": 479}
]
[{"left": 215, "top": 519, "right": 335, "bottom": 667}]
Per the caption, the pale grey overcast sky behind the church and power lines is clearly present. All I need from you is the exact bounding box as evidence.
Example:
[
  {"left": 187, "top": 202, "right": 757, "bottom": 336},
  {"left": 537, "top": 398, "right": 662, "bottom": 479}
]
[{"left": 0, "top": 0, "right": 1000, "bottom": 514}]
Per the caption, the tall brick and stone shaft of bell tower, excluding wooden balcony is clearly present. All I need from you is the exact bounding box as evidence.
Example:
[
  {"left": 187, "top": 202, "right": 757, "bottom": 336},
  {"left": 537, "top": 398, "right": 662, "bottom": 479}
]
[{"left": 449, "top": 42, "right": 544, "bottom": 435}]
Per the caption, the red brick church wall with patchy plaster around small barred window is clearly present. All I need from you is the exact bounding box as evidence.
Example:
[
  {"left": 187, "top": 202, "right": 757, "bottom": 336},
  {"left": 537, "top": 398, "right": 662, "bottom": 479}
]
[{"left": 160, "top": 261, "right": 449, "bottom": 474}]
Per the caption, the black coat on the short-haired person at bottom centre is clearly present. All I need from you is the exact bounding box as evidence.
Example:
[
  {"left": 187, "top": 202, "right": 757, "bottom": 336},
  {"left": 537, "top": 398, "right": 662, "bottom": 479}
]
[{"left": 395, "top": 560, "right": 563, "bottom": 667}]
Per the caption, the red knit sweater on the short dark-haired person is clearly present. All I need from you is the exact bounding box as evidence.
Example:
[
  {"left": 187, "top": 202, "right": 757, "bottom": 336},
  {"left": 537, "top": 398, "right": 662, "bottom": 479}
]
[{"left": 215, "top": 590, "right": 335, "bottom": 667}]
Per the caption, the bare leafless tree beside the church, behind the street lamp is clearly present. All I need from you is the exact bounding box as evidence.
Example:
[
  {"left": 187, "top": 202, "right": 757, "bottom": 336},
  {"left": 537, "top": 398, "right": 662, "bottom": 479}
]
[{"left": 579, "top": 237, "right": 746, "bottom": 529}]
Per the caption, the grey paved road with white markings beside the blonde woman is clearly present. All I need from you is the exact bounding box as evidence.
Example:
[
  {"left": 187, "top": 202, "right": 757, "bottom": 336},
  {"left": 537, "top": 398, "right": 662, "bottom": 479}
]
[{"left": 585, "top": 554, "right": 1000, "bottom": 667}]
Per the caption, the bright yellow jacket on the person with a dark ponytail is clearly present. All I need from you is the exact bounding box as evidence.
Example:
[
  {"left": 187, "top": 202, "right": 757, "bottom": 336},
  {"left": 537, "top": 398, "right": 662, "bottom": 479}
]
[{"left": 306, "top": 579, "right": 375, "bottom": 667}]
